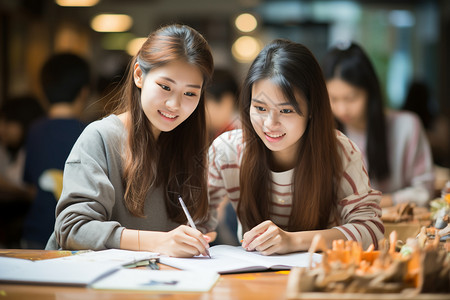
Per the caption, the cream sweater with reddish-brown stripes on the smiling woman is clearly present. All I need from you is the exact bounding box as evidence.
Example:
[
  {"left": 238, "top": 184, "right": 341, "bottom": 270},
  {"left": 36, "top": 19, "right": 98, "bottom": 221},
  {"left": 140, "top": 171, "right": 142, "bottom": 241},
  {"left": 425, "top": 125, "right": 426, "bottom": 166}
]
[{"left": 209, "top": 129, "right": 384, "bottom": 249}]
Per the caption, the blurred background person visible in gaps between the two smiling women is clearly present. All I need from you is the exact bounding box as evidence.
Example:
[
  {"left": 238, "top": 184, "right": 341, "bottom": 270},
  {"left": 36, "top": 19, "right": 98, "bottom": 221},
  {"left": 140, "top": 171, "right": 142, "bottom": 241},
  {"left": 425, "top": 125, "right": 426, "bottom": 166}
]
[{"left": 205, "top": 68, "right": 240, "bottom": 245}]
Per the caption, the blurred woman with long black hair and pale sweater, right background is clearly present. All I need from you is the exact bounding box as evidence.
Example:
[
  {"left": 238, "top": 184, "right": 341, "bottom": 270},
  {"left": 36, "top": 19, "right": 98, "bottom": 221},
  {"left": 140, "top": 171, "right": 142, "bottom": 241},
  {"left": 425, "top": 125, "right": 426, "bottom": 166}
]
[{"left": 322, "top": 43, "right": 434, "bottom": 207}]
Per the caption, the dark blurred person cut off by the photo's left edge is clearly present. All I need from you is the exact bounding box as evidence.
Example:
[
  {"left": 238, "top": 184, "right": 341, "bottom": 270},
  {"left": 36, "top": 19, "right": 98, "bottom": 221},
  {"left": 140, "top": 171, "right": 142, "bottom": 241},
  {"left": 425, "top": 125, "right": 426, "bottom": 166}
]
[{"left": 0, "top": 96, "right": 44, "bottom": 248}]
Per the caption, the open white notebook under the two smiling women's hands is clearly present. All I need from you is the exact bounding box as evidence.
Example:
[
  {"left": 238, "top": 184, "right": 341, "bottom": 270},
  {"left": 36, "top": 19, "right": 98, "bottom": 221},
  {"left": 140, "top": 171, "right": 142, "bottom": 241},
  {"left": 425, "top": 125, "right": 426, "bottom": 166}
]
[{"left": 159, "top": 245, "right": 322, "bottom": 274}]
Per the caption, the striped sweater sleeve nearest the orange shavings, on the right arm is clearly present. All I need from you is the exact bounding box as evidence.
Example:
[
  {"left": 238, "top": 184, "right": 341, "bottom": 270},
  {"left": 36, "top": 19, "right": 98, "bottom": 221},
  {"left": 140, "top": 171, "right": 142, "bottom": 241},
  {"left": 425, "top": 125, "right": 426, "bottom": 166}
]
[{"left": 335, "top": 134, "right": 384, "bottom": 249}]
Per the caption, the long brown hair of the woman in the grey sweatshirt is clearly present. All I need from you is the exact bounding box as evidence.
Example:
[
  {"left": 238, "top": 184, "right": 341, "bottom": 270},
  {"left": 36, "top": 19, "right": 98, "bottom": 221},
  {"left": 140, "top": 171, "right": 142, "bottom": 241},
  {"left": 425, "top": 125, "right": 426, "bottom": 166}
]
[{"left": 111, "top": 24, "right": 214, "bottom": 223}]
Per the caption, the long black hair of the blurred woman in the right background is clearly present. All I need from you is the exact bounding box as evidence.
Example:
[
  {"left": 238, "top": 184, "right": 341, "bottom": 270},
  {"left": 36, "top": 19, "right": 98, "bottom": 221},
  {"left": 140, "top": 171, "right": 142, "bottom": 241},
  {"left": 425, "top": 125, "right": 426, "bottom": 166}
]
[{"left": 322, "top": 43, "right": 390, "bottom": 181}]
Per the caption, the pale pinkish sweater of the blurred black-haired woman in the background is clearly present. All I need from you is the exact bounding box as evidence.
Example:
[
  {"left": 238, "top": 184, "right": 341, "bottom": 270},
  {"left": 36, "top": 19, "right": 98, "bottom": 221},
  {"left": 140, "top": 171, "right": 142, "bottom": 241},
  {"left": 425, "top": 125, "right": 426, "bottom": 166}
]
[{"left": 345, "top": 110, "right": 434, "bottom": 206}]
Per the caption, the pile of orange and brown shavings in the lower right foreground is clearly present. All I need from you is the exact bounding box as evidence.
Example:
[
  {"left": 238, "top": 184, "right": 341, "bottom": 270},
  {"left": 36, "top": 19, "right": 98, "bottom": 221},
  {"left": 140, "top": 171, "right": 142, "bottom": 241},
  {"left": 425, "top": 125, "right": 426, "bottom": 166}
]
[{"left": 289, "top": 228, "right": 450, "bottom": 295}]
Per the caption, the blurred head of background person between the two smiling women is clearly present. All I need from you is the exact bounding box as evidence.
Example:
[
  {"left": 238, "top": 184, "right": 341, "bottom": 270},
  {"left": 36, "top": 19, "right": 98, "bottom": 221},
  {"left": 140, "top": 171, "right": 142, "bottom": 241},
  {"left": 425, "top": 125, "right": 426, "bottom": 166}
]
[{"left": 206, "top": 68, "right": 240, "bottom": 141}]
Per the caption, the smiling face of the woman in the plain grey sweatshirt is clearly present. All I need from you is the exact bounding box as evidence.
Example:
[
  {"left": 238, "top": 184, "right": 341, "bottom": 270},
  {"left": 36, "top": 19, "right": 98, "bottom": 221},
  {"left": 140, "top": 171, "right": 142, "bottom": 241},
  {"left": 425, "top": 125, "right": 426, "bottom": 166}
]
[{"left": 134, "top": 60, "right": 203, "bottom": 139}]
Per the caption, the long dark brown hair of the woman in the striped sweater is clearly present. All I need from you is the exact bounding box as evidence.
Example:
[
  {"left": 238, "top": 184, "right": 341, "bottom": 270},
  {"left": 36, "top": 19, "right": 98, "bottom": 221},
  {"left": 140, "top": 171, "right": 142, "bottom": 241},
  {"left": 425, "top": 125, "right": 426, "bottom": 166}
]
[{"left": 237, "top": 39, "right": 342, "bottom": 231}]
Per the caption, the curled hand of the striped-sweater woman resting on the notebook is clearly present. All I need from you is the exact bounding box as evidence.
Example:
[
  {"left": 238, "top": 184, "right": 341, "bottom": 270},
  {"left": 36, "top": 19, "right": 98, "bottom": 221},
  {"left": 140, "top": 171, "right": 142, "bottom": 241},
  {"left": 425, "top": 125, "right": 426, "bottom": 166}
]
[{"left": 242, "top": 221, "right": 291, "bottom": 255}]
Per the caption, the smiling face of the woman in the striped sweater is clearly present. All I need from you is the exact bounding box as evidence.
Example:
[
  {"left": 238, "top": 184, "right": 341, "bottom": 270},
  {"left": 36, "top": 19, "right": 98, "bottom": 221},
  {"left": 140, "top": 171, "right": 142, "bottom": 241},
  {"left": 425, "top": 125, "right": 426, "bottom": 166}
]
[{"left": 250, "top": 79, "right": 308, "bottom": 167}]
